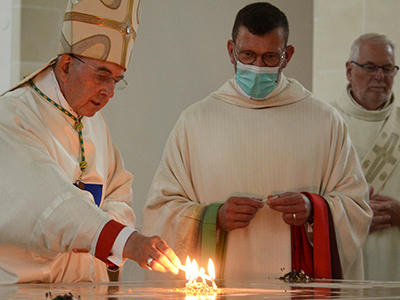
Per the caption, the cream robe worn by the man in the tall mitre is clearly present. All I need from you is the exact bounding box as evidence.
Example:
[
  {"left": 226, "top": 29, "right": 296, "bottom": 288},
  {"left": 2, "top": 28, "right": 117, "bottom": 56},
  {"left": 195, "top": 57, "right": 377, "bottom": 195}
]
[{"left": 0, "top": 69, "right": 135, "bottom": 284}]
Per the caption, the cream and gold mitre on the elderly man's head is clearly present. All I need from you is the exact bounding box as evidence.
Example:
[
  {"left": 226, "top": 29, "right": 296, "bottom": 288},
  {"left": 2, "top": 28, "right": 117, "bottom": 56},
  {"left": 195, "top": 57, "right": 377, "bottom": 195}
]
[{"left": 58, "top": 0, "right": 141, "bottom": 69}]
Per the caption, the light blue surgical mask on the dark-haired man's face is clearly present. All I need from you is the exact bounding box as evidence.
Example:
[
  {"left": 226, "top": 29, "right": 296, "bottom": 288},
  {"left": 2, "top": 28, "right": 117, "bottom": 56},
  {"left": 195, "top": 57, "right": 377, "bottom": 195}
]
[{"left": 235, "top": 61, "right": 279, "bottom": 99}]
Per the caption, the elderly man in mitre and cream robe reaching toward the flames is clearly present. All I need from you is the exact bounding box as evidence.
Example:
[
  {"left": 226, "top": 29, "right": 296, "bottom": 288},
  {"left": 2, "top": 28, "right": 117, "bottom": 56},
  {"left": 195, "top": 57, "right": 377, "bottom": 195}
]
[{"left": 0, "top": 0, "right": 180, "bottom": 284}]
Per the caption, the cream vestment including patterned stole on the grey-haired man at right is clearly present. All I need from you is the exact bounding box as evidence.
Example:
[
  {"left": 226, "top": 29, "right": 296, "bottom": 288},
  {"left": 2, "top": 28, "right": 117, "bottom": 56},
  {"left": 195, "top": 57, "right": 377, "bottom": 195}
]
[{"left": 333, "top": 86, "right": 400, "bottom": 281}]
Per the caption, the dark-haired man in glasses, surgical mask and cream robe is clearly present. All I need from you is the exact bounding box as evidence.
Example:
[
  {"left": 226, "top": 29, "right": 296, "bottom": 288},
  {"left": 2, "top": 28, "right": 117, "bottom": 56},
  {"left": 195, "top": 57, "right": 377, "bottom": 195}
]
[{"left": 142, "top": 2, "right": 372, "bottom": 282}]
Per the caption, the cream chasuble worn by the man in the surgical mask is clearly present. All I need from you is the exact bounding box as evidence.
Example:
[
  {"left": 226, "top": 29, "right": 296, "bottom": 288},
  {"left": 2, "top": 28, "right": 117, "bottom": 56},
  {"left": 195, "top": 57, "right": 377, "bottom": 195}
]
[{"left": 142, "top": 77, "right": 371, "bottom": 280}]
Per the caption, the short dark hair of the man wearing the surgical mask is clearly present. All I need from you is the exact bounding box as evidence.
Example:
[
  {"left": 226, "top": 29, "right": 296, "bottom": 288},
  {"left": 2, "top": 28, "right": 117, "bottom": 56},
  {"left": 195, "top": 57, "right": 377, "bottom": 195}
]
[{"left": 232, "top": 2, "right": 289, "bottom": 44}]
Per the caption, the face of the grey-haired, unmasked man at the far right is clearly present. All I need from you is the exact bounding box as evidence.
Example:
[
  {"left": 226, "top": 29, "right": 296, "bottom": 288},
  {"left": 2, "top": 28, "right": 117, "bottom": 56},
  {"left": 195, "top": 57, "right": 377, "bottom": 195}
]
[{"left": 346, "top": 41, "right": 395, "bottom": 110}]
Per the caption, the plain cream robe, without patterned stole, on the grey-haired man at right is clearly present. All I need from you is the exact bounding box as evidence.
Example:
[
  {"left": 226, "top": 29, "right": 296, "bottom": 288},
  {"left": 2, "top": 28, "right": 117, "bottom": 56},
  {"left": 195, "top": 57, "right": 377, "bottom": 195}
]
[{"left": 334, "top": 87, "right": 400, "bottom": 281}]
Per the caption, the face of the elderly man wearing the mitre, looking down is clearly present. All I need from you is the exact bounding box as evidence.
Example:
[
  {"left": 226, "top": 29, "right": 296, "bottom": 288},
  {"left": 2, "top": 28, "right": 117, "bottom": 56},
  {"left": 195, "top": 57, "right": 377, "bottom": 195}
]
[{"left": 63, "top": 57, "right": 124, "bottom": 117}]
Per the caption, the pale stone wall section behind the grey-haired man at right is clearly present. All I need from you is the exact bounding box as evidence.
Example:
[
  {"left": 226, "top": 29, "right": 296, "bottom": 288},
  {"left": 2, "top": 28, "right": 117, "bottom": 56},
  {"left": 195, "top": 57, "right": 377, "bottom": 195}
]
[{"left": 313, "top": 0, "right": 400, "bottom": 103}]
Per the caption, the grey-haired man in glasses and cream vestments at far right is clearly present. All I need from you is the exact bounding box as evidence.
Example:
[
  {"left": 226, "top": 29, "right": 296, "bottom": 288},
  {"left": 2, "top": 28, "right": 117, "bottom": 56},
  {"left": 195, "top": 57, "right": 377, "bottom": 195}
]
[{"left": 333, "top": 33, "right": 400, "bottom": 280}]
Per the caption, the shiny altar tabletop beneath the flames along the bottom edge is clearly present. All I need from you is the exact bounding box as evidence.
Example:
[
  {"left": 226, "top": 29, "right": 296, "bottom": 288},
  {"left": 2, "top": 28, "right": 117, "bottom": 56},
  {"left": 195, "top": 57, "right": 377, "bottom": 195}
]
[{"left": 0, "top": 279, "right": 400, "bottom": 300}]
